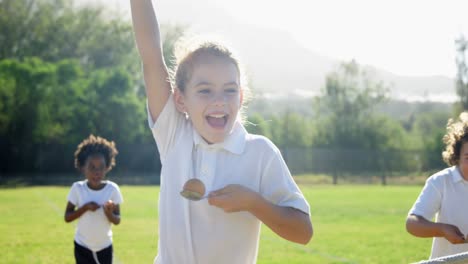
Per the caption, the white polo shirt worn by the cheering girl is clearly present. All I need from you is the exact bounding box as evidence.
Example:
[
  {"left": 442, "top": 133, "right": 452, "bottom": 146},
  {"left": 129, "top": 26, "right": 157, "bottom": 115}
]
[{"left": 148, "top": 96, "right": 309, "bottom": 264}]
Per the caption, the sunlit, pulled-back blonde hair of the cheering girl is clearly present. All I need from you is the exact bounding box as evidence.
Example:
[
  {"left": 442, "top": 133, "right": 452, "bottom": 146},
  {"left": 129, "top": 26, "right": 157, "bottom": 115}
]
[{"left": 169, "top": 36, "right": 251, "bottom": 119}]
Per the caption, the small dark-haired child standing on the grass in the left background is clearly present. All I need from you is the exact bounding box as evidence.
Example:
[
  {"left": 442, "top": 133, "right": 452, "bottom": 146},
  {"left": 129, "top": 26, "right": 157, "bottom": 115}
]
[{"left": 65, "top": 135, "right": 123, "bottom": 264}]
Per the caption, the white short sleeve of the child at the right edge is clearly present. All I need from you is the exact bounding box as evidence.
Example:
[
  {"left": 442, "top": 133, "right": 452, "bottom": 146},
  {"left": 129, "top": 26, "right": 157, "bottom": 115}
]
[{"left": 408, "top": 177, "right": 442, "bottom": 220}]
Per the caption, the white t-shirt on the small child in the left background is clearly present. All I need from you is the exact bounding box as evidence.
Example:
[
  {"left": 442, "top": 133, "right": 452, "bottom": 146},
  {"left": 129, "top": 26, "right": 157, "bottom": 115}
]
[{"left": 67, "top": 180, "right": 123, "bottom": 252}]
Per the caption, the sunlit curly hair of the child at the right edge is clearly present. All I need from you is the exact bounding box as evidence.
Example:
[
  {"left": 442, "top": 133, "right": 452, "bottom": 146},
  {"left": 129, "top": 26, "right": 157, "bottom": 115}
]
[{"left": 442, "top": 112, "right": 468, "bottom": 166}]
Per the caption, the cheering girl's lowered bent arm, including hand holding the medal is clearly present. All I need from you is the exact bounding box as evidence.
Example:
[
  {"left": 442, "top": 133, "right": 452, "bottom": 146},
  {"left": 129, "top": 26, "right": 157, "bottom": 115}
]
[{"left": 208, "top": 185, "right": 313, "bottom": 244}]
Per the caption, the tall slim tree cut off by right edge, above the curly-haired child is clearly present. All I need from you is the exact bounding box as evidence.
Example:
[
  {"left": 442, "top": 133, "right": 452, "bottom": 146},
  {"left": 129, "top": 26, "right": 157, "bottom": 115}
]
[{"left": 455, "top": 36, "right": 468, "bottom": 111}]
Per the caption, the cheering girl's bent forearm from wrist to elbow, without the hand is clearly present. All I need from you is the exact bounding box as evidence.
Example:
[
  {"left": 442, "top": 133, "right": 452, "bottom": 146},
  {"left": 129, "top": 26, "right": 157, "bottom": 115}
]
[{"left": 250, "top": 195, "right": 313, "bottom": 245}]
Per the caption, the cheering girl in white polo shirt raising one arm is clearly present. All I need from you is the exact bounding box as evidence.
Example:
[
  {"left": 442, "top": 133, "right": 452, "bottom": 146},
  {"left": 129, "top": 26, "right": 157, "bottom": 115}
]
[{"left": 131, "top": 0, "right": 312, "bottom": 264}]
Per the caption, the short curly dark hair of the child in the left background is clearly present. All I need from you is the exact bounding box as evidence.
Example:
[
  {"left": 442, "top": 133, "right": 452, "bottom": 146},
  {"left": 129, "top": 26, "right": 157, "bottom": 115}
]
[{"left": 75, "top": 134, "right": 119, "bottom": 171}]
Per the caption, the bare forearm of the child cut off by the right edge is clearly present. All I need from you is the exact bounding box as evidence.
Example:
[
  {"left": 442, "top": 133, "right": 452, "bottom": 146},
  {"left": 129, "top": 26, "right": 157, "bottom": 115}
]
[{"left": 406, "top": 214, "right": 466, "bottom": 244}]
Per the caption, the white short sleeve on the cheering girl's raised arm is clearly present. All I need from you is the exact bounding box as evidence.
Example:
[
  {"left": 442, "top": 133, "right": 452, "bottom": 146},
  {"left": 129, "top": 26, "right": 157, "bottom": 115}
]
[{"left": 150, "top": 95, "right": 185, "bottom": 162}]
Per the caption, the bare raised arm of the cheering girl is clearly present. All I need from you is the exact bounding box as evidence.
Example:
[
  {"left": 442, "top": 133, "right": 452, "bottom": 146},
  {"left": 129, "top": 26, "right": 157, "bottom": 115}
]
[{"left": 130, "top": 0, "right": 171, "bottom": 122}]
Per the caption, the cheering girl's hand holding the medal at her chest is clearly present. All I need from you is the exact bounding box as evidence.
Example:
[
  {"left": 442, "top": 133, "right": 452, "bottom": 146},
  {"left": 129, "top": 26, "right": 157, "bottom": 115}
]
[{"left": 208, "top": 184, "right": 260, "bottom": 213}]
